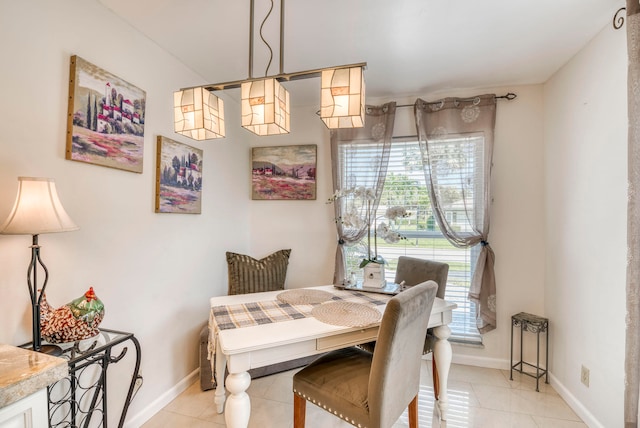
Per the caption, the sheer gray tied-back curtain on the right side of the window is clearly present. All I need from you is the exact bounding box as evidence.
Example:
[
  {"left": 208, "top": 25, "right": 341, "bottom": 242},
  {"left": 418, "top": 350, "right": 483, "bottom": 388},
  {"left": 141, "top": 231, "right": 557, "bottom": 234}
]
[{"left": 415, "top": 94, "right": 496, "bottom": 333}]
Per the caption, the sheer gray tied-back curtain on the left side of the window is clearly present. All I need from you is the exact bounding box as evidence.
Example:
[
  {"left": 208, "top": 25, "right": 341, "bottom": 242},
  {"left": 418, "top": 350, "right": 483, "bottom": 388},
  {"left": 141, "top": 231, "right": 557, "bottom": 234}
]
[{"left": 331, "top": 102, "right": 396, "bottom": 284}]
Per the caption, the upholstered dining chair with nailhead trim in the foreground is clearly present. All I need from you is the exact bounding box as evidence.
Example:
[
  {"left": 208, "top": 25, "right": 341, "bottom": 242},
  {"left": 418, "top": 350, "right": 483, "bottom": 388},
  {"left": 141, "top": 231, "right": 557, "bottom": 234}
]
[{"left": 293, "top": 281, "right": 438, "bottom": 428}]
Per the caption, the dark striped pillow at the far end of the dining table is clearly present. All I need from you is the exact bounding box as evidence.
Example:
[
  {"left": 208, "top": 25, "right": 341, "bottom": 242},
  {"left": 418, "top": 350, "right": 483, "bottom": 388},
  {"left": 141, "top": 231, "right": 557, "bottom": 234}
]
[{"left": 227, "top": 249, "right": 291, "bottom": 295}]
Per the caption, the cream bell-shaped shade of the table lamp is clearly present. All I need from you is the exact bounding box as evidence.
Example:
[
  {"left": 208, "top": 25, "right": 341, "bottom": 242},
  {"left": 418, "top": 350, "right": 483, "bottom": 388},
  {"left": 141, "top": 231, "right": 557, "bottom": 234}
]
[{"left": 0, "top": 177, "right": 79, "bottom": 235}]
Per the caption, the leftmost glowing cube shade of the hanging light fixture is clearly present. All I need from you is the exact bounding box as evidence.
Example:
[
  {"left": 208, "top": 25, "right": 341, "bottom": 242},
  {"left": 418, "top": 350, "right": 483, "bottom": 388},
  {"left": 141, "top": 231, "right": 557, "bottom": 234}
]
[{"left": 173, "top": 87, "right": 225, "bottom": 140}]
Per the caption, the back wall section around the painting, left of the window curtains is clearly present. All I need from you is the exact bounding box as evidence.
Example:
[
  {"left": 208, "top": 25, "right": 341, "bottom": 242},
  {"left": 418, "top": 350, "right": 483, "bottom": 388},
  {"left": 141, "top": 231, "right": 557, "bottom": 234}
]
[{"left": 249, "top": 102, "right": 336, "bottom": 288}]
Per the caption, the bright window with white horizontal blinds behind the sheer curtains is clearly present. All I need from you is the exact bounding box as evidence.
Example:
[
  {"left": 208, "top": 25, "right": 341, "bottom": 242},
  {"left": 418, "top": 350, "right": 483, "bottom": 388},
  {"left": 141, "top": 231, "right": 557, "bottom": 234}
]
[{"left": 340, "top": 137, "right": 482, "bottom": 344}]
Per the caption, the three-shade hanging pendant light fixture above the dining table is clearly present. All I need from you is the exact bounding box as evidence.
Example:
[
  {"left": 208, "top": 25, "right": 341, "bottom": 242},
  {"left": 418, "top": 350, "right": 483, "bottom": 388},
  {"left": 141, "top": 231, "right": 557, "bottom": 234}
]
[{"left": 174, "top": 0, "right": 367, "bottom": 140}]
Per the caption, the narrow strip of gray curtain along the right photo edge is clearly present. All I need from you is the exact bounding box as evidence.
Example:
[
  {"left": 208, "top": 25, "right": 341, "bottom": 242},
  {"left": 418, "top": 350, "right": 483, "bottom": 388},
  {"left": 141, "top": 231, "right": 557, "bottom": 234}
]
[{"left": 624, "top": 0, "right": 640, "bottom": 428}]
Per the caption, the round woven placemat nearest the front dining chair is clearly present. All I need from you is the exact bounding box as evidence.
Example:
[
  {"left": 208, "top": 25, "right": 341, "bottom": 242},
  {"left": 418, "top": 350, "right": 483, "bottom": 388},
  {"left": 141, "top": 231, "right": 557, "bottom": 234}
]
[{"left": 311, "top": 302, "right": 382, "bottom": 327}]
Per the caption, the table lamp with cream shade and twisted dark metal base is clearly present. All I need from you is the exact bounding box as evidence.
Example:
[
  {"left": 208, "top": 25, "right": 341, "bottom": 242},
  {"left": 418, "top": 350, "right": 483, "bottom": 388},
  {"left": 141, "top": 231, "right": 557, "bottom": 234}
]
[{"left": 0, "top": 177, "right": 79, "bottom": 354}]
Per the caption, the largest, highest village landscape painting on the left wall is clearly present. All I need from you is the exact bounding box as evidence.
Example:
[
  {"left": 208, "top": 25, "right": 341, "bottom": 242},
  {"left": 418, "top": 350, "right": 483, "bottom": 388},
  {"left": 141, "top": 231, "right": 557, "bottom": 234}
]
[{"left": 65, "top": 55, "right": 146, "bottom": 173}]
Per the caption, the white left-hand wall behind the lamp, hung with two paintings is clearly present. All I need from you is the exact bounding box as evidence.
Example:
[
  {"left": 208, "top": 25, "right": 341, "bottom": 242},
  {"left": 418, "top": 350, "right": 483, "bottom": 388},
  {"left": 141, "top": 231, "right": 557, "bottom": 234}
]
[{"left": 0, "top": 0, "right": 249, "bottom": 425}]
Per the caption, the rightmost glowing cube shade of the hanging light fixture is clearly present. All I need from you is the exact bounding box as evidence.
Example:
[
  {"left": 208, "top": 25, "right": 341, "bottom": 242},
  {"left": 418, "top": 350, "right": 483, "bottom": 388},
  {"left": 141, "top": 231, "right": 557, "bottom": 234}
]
[{"left": 320, "top": 67, "right": 365, "bottom": 129}]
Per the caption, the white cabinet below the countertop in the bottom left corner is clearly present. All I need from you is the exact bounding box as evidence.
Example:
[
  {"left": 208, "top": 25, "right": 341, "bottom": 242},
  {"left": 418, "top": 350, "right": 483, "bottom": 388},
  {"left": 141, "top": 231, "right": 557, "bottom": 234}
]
[{"left": 0, "top": 388, "right": 49, "bottom": 428}]
